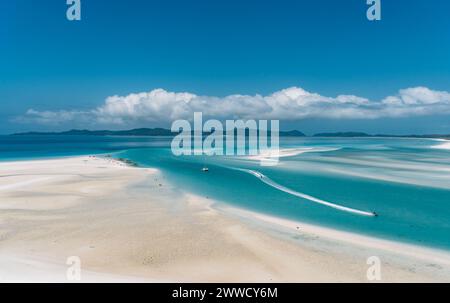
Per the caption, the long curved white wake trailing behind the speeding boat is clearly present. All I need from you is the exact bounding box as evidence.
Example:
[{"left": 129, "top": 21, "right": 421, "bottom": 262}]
[{"left": 236, "top": 168, "right": 377, "bottom": 217}]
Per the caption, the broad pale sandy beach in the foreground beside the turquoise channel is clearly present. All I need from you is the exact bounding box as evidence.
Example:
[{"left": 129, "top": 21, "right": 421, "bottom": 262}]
[{"left": 0, "top": 157, "right": 450, "bottom": 282}]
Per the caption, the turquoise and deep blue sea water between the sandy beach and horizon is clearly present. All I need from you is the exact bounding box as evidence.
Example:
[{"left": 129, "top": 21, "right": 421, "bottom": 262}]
[{"left": 0, "top": 136, "right": 450, "bottom": 250}]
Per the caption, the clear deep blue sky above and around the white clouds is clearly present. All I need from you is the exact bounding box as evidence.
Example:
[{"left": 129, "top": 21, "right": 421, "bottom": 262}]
[{"left": 0, "top": 0, "right": 450, "bottom": 133}]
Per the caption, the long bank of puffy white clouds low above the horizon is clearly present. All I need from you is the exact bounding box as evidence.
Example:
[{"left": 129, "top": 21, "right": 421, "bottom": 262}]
[{"left": 15, "top": 87, "right": 450, "bottom": 126}]
